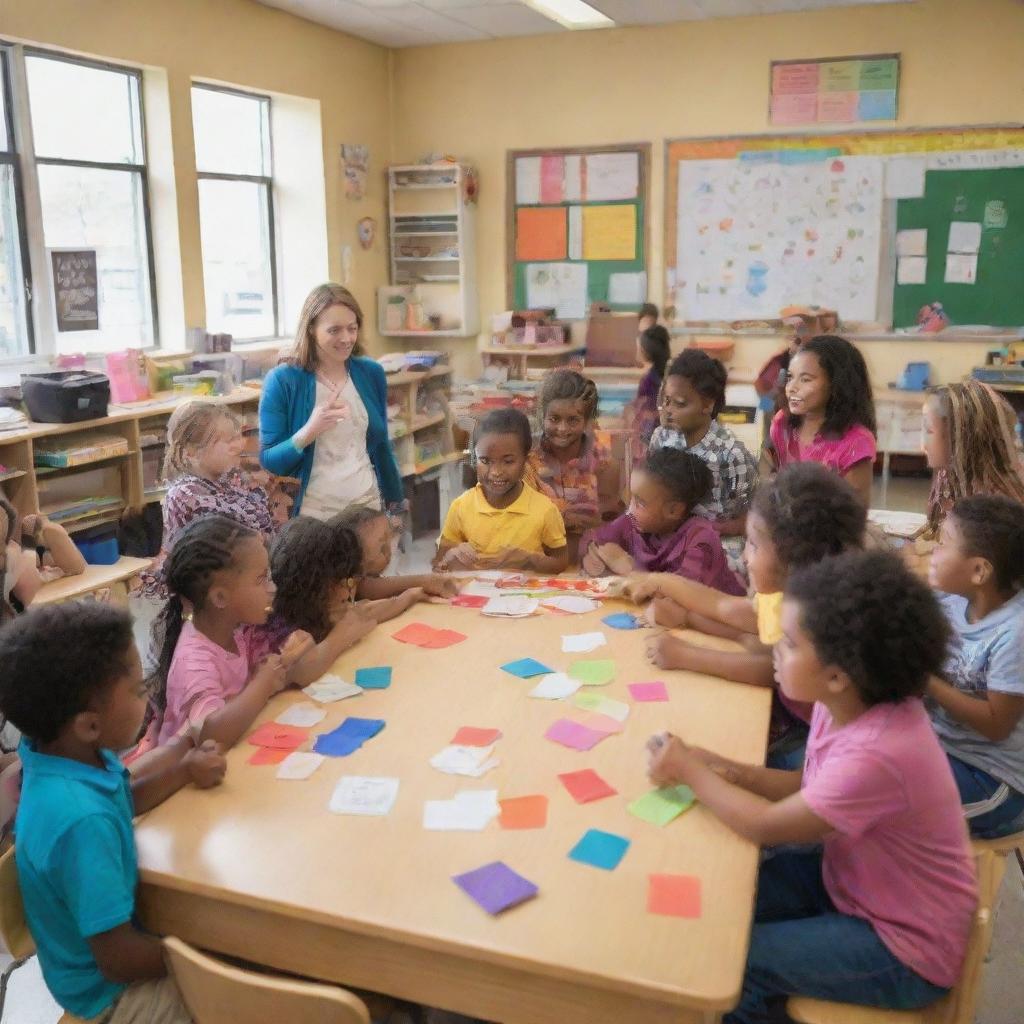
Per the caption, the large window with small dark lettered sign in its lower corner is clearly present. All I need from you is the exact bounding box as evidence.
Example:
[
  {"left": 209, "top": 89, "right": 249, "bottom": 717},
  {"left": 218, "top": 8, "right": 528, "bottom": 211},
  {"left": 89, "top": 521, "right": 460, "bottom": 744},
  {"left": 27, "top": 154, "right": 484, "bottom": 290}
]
[{"left": 25, "top": 50, "right": 157, "bottom": 353}]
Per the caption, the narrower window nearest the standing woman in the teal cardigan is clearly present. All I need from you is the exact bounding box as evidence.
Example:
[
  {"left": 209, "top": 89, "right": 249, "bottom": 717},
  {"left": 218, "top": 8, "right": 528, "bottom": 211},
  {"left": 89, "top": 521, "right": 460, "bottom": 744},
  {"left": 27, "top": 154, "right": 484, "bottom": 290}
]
[{"left": 191, "top": 85, "right": 278, "bottom": 339}]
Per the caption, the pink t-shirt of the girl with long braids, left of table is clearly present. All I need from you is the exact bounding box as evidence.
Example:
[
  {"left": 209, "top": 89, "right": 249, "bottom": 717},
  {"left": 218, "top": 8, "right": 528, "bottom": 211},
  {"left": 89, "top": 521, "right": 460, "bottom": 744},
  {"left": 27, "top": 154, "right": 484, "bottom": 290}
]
[{"left": 158, "top": 623, "right": 267, "bottom": 744}]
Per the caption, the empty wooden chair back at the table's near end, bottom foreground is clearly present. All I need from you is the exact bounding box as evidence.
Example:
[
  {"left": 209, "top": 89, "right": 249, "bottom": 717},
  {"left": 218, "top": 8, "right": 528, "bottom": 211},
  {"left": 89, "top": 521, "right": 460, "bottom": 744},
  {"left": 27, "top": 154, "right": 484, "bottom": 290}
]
[{"left": 164, "top": 938, "right": 370, "bottom": 1024}]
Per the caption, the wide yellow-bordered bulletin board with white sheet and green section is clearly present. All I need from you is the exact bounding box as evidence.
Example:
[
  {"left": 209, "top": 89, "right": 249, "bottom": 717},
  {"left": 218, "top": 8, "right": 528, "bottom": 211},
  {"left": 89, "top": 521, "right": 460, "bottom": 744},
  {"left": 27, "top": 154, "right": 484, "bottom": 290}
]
[{"left": 665, "top": 126, "right": 1024, "bottom": 327}]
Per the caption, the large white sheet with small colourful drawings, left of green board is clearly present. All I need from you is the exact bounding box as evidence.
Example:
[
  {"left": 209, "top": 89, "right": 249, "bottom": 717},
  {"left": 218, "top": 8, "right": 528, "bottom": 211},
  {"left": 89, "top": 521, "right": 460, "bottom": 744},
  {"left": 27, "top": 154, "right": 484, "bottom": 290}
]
[{"left": 675, "top": 156, "right": 883, "bottom": 321}]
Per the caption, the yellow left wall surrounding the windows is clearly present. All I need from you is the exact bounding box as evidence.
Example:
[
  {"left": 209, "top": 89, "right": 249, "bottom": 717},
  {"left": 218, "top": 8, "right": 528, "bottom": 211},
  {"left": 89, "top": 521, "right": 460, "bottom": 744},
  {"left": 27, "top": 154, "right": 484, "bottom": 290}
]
[{"left": 0, "top": 0, "right": 391, "bottom": 348}]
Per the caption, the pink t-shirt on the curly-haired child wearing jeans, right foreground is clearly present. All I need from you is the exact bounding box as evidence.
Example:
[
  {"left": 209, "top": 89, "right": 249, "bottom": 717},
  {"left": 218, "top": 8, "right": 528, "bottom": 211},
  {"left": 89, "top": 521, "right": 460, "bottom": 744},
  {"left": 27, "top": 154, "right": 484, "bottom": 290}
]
[{"left": 801, "top": 698, "right": 978, "bottom": 987}]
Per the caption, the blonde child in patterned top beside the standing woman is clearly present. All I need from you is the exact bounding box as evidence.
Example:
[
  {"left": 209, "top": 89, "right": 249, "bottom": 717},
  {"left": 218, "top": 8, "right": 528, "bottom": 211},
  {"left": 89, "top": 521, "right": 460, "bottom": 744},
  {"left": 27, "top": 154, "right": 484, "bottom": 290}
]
[{"left": 142, "top": 401, "right": 278, "bottom": 598}]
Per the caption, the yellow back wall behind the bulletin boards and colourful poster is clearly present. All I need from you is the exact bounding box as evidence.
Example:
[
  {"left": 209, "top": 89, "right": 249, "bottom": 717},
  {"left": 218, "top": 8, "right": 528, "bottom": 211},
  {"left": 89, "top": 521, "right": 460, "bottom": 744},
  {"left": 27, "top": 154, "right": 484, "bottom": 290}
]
[{"left": 392, "top": 0, "right": 1024, "bottom": 383}]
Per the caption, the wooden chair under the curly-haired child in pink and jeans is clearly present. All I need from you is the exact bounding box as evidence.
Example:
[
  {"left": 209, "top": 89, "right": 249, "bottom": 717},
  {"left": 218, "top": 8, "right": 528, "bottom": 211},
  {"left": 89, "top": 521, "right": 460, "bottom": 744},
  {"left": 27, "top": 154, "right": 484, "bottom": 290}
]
[{"left": 785, "top": 841, "right": 1007, "bottom": 1024}]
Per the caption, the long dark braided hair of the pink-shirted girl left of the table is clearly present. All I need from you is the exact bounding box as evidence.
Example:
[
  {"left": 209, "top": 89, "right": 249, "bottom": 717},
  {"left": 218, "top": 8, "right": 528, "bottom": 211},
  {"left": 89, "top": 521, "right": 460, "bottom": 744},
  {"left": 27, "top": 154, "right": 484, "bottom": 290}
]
[{"left": 146, "top": 515, "right": 259, "bottom": 711}]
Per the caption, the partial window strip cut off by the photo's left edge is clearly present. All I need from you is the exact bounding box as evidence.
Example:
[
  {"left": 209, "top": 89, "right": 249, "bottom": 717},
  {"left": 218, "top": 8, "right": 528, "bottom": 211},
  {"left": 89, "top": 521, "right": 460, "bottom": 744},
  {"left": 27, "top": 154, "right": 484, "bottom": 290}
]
[{"left": 0, "top": 51, "right": 33, "bottom": 359}]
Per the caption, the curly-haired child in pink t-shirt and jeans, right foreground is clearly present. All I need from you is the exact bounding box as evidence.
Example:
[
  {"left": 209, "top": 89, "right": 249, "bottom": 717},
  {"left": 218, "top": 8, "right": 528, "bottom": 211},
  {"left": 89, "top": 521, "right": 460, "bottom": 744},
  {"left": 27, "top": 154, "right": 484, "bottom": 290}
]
[{"left": 648, "top": 552, "right": 977, "bottom": 1024}]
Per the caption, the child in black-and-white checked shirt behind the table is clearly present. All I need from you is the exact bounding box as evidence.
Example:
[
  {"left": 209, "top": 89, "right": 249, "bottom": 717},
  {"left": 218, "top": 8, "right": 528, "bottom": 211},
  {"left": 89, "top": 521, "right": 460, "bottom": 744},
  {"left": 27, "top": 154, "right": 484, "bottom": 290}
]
[{"left": 650, "top": 348, "right": 758, "bottom": 571}]
